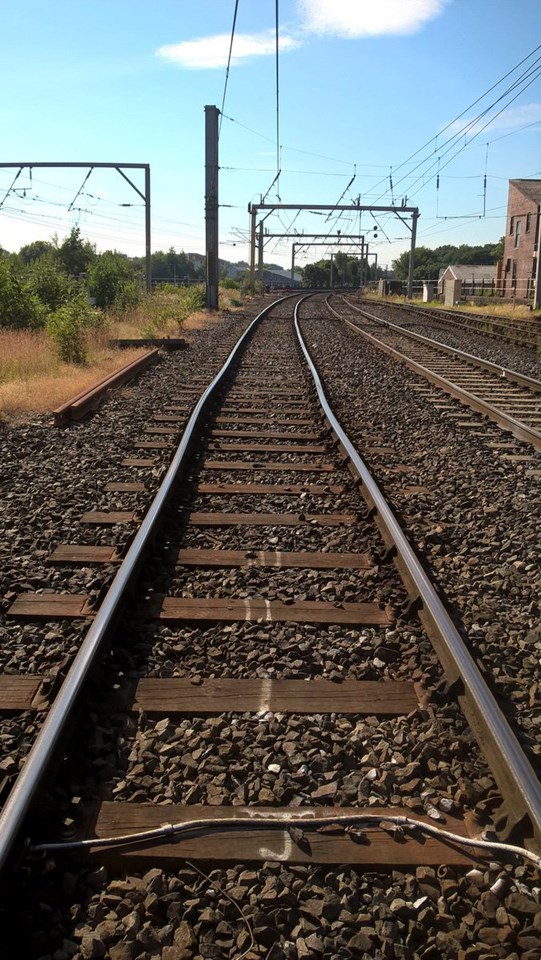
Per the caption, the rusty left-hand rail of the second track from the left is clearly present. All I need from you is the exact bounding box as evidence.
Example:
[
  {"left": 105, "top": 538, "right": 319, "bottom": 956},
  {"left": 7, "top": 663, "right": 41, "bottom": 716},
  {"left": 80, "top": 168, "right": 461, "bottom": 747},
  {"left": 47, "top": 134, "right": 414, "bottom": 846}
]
[{"left": 326, "top": 300, "right": 541, "bottom": 450}]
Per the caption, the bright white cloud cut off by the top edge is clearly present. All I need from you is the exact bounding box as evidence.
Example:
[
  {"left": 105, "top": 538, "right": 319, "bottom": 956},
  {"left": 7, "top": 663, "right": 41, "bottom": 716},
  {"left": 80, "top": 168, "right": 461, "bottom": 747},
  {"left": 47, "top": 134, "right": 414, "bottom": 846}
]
[{"left": 298, "top": 0, "right": 449, "bottom": 38}]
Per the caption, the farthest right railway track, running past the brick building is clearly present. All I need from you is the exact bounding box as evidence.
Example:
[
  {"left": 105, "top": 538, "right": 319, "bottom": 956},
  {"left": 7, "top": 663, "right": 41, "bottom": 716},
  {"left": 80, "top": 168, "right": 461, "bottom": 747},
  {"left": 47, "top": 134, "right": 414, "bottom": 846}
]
[{"left": 359, "top": 300, "right": 541, "bottom": 351}]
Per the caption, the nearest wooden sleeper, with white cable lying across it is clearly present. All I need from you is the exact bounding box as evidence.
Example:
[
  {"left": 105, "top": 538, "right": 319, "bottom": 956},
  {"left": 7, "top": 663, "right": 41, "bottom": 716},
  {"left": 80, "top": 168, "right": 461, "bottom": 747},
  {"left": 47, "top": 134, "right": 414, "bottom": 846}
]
[{"left": 79, "top": 801, "right": 472, "bottom": 871}]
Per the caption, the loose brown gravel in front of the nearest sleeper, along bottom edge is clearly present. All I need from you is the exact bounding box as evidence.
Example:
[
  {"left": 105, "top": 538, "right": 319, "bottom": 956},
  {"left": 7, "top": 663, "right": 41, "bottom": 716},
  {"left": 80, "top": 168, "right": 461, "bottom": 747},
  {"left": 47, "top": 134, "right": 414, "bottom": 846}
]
[{"left": 4, "top": 862, "right": 541, "bottom": 960}]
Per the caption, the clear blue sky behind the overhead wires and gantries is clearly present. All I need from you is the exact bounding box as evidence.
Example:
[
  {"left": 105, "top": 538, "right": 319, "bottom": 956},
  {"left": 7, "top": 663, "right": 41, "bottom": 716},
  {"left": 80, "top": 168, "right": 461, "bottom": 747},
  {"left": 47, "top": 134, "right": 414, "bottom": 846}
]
[{"left": 0, "top": 0, "right": 541, "bottom": 266}]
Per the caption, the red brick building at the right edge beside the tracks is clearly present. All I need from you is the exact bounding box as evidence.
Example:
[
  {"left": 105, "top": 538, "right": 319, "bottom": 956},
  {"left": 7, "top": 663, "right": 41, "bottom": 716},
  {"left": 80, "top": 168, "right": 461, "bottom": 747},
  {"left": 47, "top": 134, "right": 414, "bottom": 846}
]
[{"left": 501, "top": 180, "right": 541, "bottom": 303}]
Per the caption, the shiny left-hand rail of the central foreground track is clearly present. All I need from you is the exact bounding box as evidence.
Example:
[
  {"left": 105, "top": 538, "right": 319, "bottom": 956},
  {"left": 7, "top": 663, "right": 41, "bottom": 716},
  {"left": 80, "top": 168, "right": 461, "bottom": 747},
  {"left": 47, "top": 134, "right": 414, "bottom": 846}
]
[{"left": 0, "top": 297, "right": 296, "bottom": 871}]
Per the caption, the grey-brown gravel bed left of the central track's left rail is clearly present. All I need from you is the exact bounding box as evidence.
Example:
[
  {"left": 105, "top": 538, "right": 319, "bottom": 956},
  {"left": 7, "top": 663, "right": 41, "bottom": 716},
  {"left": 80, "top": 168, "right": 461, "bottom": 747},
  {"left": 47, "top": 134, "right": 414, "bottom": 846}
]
[{"left": 0, "top": 316, "right": 253, "bottom": 792}]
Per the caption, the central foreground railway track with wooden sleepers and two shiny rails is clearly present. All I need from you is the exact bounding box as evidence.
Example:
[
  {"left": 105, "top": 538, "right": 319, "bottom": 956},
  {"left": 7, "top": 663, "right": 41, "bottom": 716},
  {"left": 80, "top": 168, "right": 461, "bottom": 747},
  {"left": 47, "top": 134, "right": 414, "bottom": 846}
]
[{"left": 1, "top": 300, "right": 541, "bottom": 955}]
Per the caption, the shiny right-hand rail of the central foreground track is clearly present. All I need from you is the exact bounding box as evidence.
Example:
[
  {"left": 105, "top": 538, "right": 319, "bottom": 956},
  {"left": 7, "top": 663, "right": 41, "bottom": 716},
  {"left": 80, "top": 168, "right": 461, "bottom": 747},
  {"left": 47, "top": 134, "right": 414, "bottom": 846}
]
[{"left": 294, "top": 298, "right": 541, "bottom": 846}]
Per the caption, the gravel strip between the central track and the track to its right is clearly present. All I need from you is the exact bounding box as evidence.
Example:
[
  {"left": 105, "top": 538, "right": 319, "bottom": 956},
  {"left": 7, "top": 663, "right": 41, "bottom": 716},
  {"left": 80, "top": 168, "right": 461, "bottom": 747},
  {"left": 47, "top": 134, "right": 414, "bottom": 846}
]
[{"left": 302, "top": 304, "right": 541, "bottom": 760}]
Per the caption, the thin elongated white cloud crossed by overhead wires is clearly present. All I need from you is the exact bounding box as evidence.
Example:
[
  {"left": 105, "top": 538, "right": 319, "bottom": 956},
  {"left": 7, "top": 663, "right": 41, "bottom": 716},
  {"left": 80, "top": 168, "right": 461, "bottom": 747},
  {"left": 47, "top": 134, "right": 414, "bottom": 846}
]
[{"left": 156, "top": 30, "right": 301, "bottom": 70}]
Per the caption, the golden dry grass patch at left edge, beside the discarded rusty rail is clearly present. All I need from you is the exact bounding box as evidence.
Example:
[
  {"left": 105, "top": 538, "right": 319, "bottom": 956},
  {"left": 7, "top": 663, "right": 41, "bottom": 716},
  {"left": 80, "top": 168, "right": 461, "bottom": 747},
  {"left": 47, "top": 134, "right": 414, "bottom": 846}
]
[{"left": 0, "top": 330, "right": 142, "bottom": 422}]
